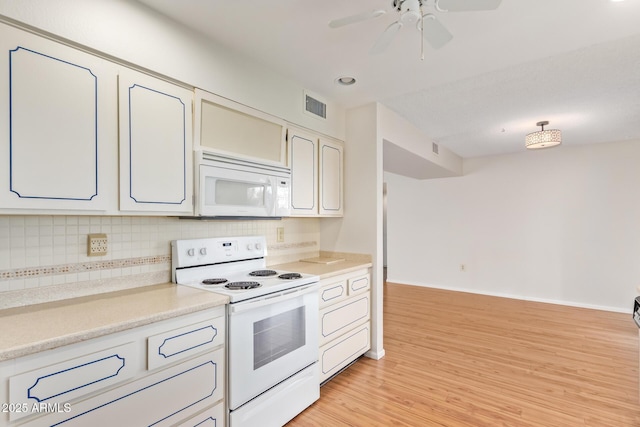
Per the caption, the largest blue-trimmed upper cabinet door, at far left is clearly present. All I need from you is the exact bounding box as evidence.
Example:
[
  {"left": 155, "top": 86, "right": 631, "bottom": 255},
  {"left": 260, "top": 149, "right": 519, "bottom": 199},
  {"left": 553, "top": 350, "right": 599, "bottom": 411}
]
[{"left": 0, "top": 24, "right": 117, "bottom": 212}]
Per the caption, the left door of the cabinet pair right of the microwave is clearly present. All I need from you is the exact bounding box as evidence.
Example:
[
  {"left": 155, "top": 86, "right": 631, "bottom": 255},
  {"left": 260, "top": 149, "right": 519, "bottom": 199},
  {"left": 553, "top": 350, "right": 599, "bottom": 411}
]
[{"left": 289, "top": 130, "right": 318, "bottom": 216}]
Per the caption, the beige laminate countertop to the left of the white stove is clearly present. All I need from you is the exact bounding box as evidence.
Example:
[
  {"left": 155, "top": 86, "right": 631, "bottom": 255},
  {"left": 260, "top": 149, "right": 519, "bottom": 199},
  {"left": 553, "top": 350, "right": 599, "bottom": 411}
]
[{"left": 0, "top": 283, "right": 229, "bottom": 361}]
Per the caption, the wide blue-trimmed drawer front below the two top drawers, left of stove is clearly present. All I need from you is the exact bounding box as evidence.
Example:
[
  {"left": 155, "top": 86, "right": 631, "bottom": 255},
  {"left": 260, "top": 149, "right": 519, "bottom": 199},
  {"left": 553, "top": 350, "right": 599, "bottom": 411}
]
[{"left": 26, "top": 349, "right": 224, "bottom": 427}]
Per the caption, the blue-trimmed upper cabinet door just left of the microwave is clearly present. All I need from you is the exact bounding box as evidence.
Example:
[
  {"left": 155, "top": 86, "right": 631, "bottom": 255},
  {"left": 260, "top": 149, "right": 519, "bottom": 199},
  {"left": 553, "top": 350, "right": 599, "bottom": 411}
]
[{"left": 118, "top": 69, "right": 193, "bottom": 214}]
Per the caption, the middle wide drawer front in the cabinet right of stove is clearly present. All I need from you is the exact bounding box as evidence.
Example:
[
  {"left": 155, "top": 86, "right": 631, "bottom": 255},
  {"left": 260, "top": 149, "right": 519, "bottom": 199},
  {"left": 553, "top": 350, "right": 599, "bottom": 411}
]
[{"left": 320, "top": 294, "right": 371, "bottom": 345}]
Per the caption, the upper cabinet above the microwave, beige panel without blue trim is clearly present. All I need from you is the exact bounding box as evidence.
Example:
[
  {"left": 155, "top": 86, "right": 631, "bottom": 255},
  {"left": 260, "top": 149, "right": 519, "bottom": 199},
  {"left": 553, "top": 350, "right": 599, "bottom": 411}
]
[{"left": 194, "top": 89, "right": 287, "bottom": 166}]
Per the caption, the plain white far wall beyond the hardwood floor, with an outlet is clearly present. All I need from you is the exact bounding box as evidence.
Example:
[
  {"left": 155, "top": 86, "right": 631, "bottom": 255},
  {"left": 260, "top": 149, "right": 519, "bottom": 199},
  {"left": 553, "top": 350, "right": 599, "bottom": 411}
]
[{"left": 385, "top": 141, "right": 640, "bottom": 311}]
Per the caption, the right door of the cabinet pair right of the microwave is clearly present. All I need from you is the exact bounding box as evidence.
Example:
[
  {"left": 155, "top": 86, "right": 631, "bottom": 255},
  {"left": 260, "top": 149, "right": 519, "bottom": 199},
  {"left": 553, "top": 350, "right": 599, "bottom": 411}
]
[{"left": 319, "top": 139, "right": 344, "bottom": 216}]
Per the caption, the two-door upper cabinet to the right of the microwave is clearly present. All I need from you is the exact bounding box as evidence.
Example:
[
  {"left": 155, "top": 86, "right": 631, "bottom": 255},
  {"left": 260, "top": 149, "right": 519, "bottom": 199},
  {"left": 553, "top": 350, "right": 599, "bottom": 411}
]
[{"left": 288, "top": 128, "right": 344, "bottom": 216}]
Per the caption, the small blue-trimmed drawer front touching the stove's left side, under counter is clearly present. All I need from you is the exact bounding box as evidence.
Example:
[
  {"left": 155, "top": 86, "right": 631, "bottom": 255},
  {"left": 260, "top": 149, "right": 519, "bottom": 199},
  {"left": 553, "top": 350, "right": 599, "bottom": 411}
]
[{"left": 147, "top": 317, "right": 225, "bottom": 370}]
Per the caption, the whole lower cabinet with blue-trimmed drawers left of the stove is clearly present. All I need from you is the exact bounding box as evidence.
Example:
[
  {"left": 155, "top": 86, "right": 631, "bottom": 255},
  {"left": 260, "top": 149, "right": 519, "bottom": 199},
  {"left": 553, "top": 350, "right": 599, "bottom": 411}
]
[{"left": 0, "top": 307, "right": 225, "bottom": 427}]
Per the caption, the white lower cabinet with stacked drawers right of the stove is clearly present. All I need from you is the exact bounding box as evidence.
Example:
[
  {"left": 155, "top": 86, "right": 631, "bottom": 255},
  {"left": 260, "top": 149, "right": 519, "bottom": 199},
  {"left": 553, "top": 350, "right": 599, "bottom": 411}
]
[{"left": 319, "top": 269, "right": 371, "bottom": 383}]
